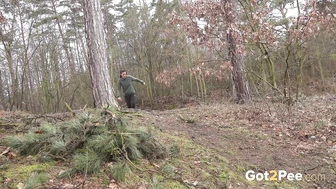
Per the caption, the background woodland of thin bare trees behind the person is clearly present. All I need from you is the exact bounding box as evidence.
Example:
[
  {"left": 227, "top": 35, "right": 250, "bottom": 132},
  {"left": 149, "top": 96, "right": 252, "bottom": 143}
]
[{"left": 0, "top": 0, "right": 336, "bottom": 113}]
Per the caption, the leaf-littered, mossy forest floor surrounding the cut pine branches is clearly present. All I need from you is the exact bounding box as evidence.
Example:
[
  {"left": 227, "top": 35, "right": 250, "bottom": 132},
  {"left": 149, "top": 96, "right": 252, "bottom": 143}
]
[{"left": 0, "top": 96, "right": 336, "bottom": 189}]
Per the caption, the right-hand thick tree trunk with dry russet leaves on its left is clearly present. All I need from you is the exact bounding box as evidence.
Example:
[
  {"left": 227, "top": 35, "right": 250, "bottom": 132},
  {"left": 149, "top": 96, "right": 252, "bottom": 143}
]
[{"left": 172, "top": 0, "right": 251, "bottom": 103}]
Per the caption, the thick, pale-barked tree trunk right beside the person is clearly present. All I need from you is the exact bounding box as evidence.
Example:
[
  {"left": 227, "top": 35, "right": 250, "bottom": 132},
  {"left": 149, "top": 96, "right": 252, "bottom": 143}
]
[{"left": 83, "top": 0, "right": 119, "bottom": 107}]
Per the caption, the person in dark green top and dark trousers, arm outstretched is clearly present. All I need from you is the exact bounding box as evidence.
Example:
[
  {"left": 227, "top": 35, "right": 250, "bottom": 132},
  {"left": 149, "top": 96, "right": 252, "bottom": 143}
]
[{"left": 117, "top": 70, "right": 146, "bottom": 108}]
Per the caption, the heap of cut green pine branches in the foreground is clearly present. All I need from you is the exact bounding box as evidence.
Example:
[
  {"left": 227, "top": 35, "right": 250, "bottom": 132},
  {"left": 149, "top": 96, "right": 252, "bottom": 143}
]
[{"left": 5, "top": 110, "right": 167, "bottom": 180}]
